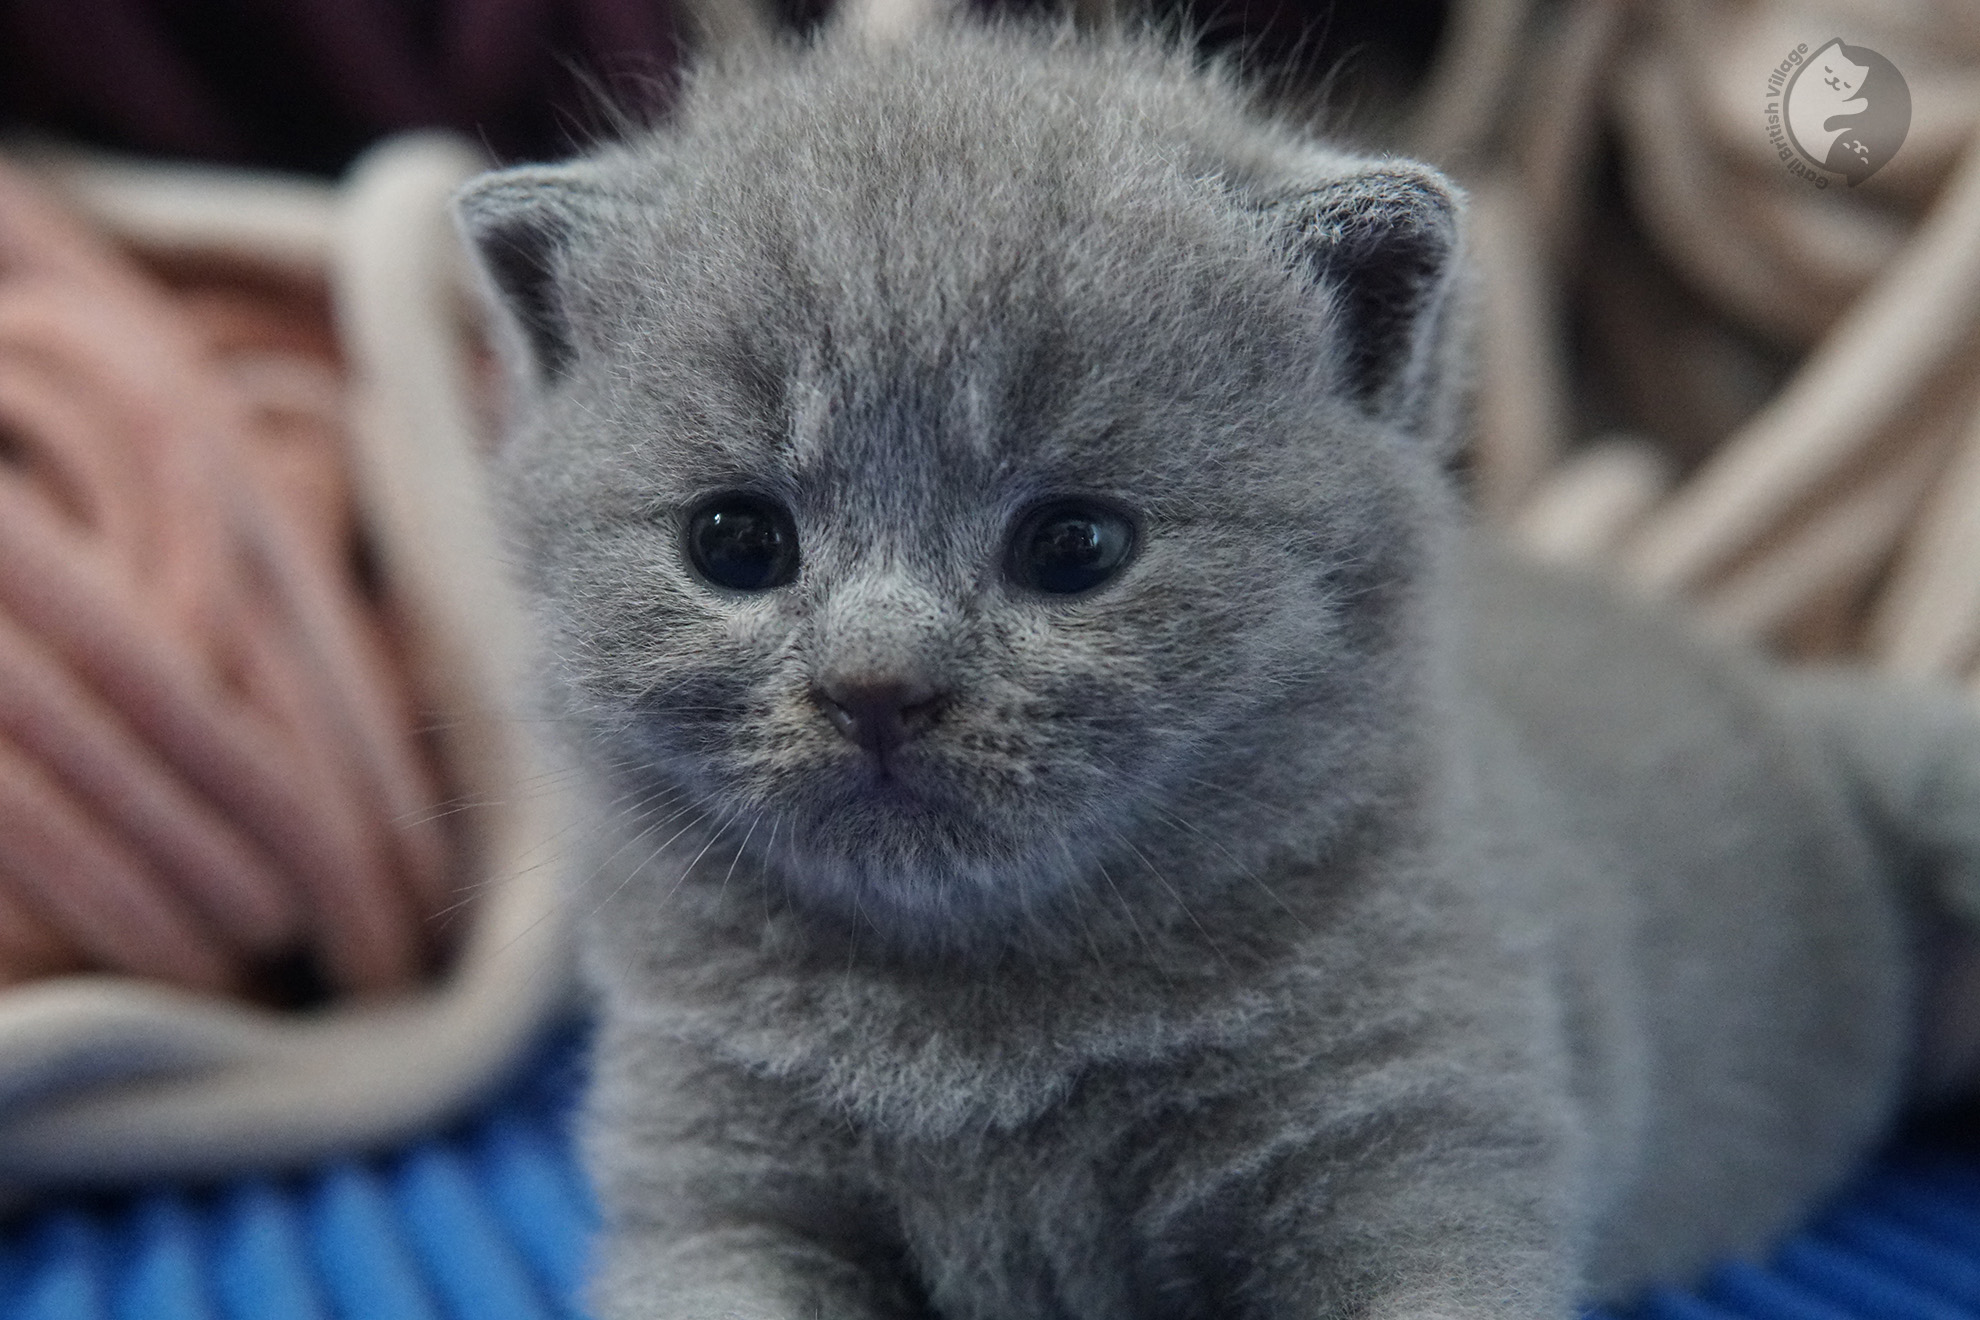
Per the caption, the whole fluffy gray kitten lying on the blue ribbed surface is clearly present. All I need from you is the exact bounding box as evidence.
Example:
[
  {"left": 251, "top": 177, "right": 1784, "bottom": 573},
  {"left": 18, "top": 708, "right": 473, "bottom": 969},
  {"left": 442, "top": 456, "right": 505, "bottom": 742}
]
[{"left": 459, "top": 24, "right": 1980, "bottom": 1320}]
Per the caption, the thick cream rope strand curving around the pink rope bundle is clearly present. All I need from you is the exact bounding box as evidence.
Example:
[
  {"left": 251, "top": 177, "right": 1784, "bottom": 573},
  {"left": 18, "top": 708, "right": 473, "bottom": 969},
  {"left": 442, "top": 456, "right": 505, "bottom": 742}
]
[{"left": 0, "top": 135, "right": 572, "bottom": 1197}]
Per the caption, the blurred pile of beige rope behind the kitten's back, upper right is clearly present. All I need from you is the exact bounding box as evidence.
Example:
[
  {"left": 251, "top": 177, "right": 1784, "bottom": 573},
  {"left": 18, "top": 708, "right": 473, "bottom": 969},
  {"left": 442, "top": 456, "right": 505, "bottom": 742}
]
[{"left": 1416, "top": 0, "right": 1980, "bottom": 677}]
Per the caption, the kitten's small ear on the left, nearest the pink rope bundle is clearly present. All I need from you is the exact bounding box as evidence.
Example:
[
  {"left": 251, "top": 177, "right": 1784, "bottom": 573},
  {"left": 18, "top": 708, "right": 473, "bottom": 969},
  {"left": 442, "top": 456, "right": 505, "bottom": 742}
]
[{"left": 453, "top": 162, "right": 604, "bottom": 384}]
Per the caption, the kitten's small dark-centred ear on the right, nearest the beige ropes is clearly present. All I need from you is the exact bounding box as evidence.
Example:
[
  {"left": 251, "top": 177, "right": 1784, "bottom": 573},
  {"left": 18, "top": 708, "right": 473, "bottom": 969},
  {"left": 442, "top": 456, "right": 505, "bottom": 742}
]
[{"left": 1265, "top": 160, "right": 1463, "bottom": 429}]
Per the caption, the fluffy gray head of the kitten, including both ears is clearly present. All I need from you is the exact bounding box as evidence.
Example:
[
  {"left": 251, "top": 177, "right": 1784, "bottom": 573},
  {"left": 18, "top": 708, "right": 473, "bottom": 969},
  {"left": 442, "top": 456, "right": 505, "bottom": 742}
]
[{"left": 461, "top": 20, "right": 1455, "bottom": 944}]
